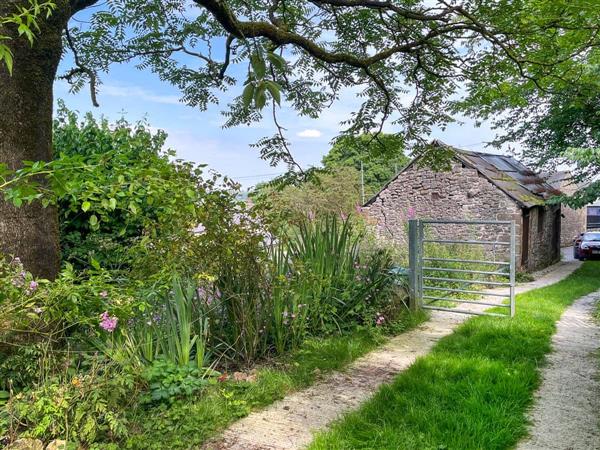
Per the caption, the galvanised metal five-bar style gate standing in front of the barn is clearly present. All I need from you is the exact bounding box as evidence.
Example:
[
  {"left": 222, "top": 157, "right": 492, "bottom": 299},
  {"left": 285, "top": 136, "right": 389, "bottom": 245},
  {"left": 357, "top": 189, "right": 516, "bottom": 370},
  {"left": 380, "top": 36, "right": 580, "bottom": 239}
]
[{"left": 408, "top": 219, "right": 516, "bottom": 317}]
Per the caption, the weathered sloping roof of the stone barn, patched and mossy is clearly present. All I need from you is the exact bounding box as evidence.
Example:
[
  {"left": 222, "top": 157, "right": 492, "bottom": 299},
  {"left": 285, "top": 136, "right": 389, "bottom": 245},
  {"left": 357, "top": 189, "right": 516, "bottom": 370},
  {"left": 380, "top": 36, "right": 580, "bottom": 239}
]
[{"left": 367, "top": 140, "right": 561, "bottom": 208}]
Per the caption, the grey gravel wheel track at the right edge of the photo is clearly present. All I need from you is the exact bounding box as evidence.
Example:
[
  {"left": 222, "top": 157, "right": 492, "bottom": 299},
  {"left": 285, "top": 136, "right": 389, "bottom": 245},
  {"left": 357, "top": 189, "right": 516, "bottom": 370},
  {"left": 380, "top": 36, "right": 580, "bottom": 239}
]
[{"left": 517, "top": 291, "right": 600, "bottom": 450}]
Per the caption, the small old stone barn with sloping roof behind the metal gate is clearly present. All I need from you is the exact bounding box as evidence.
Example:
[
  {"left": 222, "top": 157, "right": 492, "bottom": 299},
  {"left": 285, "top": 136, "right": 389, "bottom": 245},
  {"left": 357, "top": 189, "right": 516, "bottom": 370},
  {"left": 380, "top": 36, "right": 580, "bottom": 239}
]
[{"left": 363, "top": 141, "right": 561, "bottom": 271}]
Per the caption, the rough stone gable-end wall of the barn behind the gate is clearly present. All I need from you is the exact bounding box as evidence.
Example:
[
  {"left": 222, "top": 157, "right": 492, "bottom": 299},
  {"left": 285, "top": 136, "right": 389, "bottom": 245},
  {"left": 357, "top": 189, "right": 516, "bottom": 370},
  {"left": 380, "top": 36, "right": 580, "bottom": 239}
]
[{"left": 364, "top": 162, "right": 522, "bottom": 268}]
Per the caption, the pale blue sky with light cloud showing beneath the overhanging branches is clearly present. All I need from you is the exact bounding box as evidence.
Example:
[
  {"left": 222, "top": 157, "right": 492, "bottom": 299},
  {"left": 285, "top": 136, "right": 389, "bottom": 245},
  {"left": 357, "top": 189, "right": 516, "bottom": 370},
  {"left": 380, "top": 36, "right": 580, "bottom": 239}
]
[{"left": 55, "top": 9, "right": 506, "bottom": 187}]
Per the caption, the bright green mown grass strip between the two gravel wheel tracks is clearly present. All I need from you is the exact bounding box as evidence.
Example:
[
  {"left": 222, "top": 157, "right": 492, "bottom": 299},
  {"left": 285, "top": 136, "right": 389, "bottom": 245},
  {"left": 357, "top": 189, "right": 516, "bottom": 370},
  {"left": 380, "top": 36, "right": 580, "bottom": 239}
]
[{"left": 310, "top": 262, "right": 600, "bottom": 450}]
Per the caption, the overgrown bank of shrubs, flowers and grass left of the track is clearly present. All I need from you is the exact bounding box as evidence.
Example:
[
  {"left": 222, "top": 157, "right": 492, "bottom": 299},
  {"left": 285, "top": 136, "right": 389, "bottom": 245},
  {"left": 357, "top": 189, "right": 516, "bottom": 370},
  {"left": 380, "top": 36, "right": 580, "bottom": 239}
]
[{"left": 0, "top": 109, "right": 414, "bottom": 449}]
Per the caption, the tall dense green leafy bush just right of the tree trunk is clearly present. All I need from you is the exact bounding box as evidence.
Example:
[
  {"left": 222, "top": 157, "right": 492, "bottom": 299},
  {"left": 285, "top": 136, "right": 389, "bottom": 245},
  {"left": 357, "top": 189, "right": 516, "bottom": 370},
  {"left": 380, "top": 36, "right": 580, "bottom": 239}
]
[{"left": 54, "top": 107, "right": 208, "bottom": 269}]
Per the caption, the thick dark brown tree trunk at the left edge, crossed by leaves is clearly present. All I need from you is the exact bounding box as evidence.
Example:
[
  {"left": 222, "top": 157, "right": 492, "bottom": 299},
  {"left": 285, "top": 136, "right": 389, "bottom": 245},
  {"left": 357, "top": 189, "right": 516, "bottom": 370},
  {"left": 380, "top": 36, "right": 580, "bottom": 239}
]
[{"left": 0, "top": 0, "right": 69, "bottom": 279}]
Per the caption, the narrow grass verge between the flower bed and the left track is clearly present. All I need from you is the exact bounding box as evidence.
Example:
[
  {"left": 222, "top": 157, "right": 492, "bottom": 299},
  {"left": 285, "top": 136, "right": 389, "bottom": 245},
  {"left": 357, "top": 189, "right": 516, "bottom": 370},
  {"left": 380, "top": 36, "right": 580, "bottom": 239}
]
[{"left": 126, "top": 314, "right": 425, "bottom": 449}]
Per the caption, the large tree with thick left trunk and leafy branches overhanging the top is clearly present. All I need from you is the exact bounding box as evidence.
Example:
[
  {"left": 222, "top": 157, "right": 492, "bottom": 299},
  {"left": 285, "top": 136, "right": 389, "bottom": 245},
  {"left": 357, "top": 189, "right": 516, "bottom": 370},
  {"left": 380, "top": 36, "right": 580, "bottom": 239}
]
[{"left": 0, "top": 0, "right": 600, "bottom": 276}]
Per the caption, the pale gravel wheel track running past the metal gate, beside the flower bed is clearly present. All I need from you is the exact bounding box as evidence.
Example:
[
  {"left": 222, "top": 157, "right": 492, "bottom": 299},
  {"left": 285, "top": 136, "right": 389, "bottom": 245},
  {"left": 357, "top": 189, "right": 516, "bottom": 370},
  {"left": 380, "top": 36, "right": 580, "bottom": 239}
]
[{"left": 203, "top": 261, "right": 580, "bottom": 450}]
